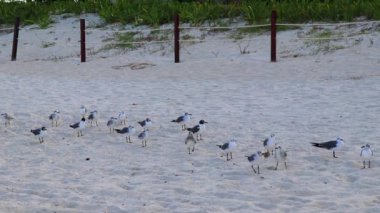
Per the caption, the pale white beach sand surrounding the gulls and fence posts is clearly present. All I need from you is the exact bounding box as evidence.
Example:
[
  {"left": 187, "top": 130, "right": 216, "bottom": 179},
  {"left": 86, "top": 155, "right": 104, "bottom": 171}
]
[{"left": 0, "top": 16, "right": 380, "bottom": 213}]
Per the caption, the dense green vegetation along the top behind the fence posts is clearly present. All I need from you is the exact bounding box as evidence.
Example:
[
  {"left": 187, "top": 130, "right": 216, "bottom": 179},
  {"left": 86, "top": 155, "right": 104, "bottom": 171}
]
[{"left": 0, "top": 0, "right": 380, "bottom": 28}]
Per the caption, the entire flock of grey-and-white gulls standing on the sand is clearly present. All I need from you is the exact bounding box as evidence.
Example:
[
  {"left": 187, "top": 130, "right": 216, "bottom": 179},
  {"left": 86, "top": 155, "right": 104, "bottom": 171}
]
[{"left": 0, "top": 106, "right": 373, "bottom": 174}]
